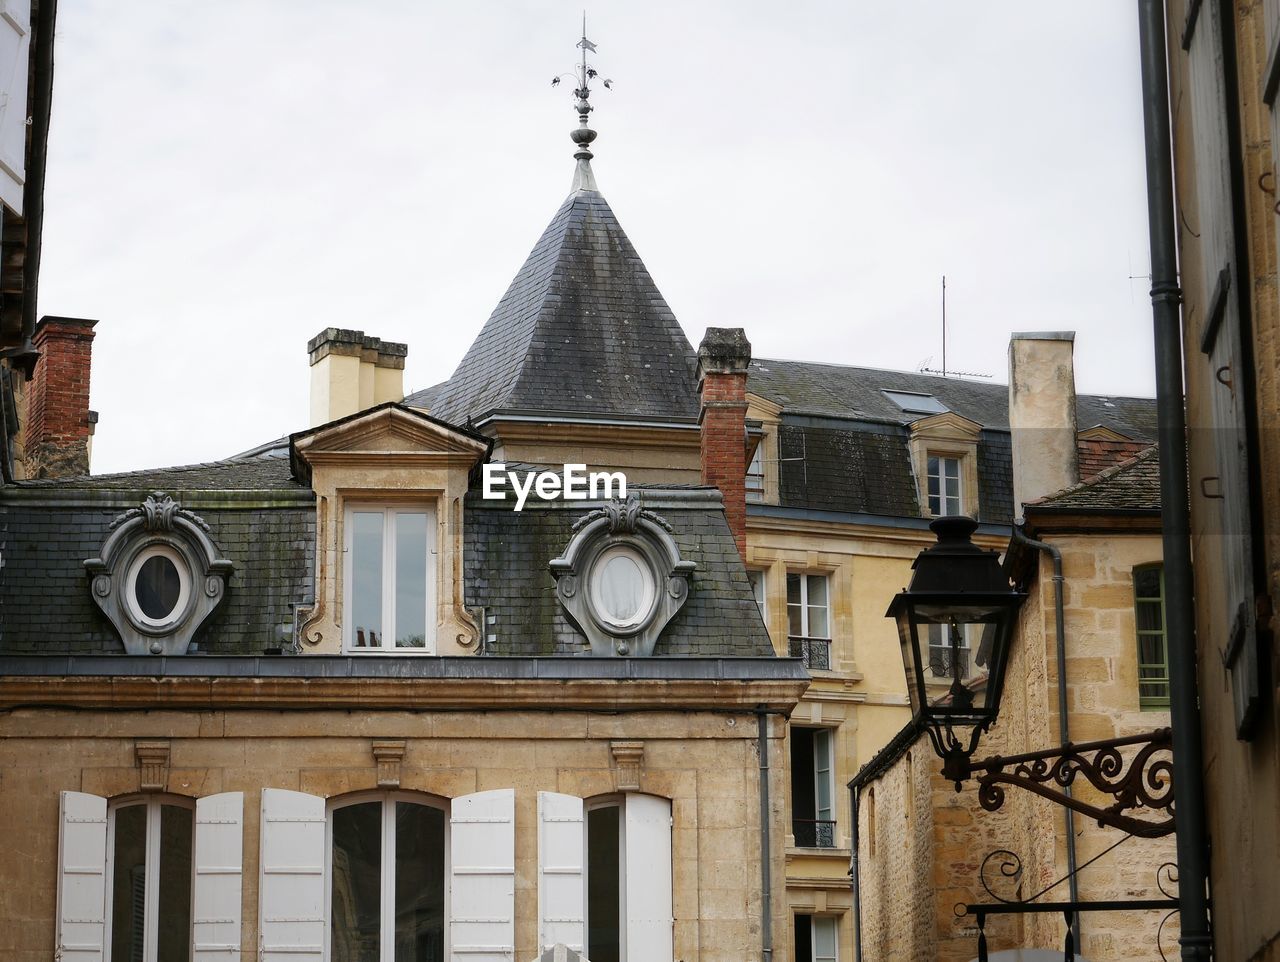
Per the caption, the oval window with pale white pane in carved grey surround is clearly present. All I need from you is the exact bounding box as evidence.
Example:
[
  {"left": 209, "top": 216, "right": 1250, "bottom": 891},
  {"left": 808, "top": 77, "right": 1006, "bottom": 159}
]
[{"left": 550, "top": 496, "right": 698, "bottom": 656}]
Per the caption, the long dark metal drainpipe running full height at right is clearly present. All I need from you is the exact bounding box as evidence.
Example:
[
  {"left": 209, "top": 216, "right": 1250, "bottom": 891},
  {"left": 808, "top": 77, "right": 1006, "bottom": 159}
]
[{"left": 1138, "top": 0, "right": 1213, "bottom": 962}]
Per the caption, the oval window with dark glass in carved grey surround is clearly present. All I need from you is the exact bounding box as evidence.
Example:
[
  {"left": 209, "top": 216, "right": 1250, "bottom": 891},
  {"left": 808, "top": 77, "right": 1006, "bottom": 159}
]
[{"left": 84, "top": 493, "right": 234, "bottom": 655}]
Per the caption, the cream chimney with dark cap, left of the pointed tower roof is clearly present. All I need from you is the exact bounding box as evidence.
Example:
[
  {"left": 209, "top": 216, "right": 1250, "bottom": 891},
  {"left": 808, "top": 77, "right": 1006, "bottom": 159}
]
[{"left": 307, "top": 327, "right": 408, "bottom": 427}]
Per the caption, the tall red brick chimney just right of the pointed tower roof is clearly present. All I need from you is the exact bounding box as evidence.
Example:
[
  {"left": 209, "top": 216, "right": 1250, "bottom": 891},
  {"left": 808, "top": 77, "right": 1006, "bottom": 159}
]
[{"left": 698, "top": 327, "right": 751, "bottom": 559}]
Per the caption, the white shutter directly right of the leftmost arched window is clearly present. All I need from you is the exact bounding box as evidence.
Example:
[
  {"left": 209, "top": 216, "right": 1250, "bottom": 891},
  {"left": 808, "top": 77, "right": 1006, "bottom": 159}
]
[{"left": 192, "top": 792, "right": 244, "bottom": 962}]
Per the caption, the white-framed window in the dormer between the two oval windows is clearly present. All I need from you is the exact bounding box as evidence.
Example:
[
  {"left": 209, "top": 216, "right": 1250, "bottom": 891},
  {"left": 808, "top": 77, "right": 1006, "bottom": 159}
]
[{"left": 344, "top": 504, "right": 435, "bottom": 654}]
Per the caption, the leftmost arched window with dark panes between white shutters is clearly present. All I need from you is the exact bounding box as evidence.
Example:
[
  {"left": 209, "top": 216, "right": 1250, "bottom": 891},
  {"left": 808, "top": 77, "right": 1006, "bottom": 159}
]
[{"left": 105, "top": 794, "right": 196, "bottom": 962}]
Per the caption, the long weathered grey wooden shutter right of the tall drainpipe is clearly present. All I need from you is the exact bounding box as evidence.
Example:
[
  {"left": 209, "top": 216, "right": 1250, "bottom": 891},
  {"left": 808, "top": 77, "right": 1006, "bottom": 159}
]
[{"left": 1188, "top": 3, "right": 1261, "bottom": 738}]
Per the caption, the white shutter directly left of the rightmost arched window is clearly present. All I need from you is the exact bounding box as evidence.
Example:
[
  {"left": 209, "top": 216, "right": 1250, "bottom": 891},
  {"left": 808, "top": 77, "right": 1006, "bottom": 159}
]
[{"left": 538, "top": 792, "right": 585, "bottom": 952}]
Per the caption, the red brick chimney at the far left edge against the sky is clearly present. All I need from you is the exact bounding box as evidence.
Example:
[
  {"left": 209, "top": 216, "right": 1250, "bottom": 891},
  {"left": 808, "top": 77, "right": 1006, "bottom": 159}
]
[{"left": 23, "top": 316, "right": 97, "bottom": 477}]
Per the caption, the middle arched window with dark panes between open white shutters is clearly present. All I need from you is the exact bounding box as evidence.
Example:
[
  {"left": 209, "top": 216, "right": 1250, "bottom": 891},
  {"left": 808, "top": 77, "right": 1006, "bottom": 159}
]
[{"left": 326, "top": 792, "right": 448, "bottom": 962}]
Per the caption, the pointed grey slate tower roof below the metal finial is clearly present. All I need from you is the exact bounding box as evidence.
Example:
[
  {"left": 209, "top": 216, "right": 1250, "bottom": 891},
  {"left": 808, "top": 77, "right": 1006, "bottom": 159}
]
[{"left": 424, "top": 180, "right": 698, "bottom": 423}]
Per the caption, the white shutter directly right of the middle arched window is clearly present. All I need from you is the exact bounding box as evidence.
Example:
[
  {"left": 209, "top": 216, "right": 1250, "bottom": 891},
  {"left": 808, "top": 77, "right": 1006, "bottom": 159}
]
[{"left": 449, "top": 788, "right": 516, "bottom": 962}]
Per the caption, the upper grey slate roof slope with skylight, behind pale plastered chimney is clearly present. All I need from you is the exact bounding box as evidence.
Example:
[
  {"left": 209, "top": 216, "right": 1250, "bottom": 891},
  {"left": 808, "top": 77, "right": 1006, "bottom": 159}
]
[{"left": 748, "top": 358, "right": 1156, "bottom": 441}]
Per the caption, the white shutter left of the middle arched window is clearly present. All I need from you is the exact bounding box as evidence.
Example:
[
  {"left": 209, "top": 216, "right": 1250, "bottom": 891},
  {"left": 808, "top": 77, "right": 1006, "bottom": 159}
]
[{"left": 257, "top": 788, "right": 325, "bottom": 962}]
